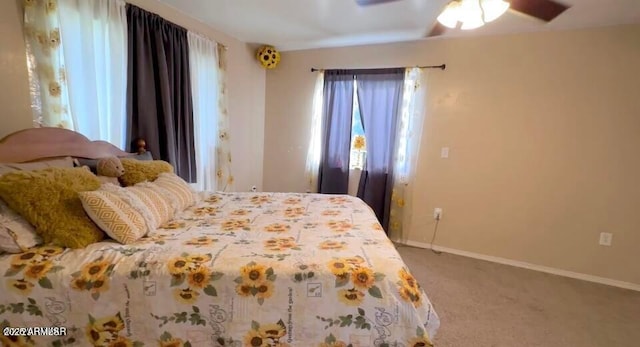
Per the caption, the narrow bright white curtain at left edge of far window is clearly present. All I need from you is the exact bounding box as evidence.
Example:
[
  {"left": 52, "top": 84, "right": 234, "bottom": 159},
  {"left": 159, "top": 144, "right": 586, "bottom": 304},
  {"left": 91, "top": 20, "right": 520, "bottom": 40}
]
[{"left": 305, "top": 71, "right": 324, "bottom": 193}]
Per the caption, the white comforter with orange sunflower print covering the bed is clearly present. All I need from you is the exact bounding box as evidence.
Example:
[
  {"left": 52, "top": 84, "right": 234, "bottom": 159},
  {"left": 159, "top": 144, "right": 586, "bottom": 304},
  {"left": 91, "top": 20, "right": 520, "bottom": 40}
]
[{"left": 0, "top": 193, "right": 439, "bottom": 347}]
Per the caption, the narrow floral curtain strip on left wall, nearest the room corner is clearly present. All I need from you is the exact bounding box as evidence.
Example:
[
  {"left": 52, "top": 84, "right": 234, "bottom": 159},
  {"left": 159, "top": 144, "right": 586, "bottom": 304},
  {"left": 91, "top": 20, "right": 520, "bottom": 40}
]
[{"left": 216, "top": 44, "right": 233, "bottom": 192}]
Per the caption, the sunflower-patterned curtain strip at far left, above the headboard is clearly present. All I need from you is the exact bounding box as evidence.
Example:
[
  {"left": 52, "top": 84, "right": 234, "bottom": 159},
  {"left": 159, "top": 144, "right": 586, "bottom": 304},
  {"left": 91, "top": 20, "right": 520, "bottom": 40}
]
[{"left": 24, "top": 0, "right": 75, "bottom": 130}]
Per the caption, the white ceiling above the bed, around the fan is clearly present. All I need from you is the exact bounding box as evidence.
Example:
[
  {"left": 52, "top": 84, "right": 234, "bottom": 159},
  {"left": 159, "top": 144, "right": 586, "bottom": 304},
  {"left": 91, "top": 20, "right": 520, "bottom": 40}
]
[{"left": 159, "top": 0, "right": 640, "bottom": 51}]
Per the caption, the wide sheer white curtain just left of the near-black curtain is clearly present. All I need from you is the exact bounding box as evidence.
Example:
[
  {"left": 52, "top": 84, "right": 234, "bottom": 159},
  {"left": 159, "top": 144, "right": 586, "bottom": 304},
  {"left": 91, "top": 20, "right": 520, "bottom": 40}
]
[{"left": 58, "top": 0, "right": 127, "bottom": 148}]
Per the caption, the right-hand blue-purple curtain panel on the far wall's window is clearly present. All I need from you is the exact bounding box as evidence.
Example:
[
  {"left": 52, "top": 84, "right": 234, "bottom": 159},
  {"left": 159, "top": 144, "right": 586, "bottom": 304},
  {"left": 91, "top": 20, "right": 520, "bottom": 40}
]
[{"left": 355, "top": 68, "right": 405, "bottom": 230}]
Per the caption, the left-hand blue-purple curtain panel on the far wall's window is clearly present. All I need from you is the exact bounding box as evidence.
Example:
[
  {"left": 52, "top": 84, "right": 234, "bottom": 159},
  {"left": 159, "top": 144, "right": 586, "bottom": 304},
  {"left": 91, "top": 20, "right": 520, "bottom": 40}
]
[{"left": 318, "top": 70, "right": 353, "bottom": 194}]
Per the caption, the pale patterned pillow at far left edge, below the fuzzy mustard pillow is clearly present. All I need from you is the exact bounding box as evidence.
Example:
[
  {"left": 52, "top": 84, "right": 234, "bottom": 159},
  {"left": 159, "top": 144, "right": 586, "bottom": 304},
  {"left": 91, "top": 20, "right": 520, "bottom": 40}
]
[{"left": 0, "top": 200, "right": 42, "bottom": 253}]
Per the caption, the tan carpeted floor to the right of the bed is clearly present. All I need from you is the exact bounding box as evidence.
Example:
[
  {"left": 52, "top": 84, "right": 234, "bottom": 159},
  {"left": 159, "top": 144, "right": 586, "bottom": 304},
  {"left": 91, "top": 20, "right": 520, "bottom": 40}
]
[{"left": 398, "top": 246, "right": 640, "bottom": 347}]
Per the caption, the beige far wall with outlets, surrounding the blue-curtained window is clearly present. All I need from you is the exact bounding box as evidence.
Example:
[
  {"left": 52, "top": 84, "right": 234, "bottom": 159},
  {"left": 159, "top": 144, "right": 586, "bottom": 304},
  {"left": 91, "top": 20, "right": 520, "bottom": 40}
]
[{"left": 264, "top": 25, "right": 640, "bottom": 284}]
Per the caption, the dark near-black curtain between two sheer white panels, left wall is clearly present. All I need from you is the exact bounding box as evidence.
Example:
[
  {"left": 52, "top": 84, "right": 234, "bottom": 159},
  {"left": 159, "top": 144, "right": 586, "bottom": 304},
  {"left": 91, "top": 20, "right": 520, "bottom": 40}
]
[{"left": 127, "top": 4, "right": 196, "bottom": 182}]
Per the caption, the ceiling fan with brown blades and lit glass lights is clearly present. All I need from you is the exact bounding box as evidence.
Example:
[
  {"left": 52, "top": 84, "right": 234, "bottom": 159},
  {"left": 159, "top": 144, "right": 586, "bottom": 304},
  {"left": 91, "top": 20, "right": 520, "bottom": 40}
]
[{"left": 355, "top": 0, "right": 569, "bottom": 37}]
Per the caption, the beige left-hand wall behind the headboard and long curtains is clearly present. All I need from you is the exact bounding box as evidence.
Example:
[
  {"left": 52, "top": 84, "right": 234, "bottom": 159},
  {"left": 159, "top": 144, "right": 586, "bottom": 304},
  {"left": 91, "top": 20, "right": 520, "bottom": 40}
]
[{"left": 0, "top": 0, "right": 265, "bottom": 191}]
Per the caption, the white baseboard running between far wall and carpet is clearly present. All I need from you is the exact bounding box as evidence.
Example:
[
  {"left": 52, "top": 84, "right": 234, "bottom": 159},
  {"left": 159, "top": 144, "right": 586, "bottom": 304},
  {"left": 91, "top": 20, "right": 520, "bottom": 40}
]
[{"left": 394, "top": 240, "right": 640, "bottom": 292}]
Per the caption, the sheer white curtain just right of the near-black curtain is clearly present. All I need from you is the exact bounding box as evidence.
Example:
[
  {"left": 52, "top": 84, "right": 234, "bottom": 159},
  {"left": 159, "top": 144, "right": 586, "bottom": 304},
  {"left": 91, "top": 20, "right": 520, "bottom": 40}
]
[{"left": 187, "top": 32, "right": 222, "bottom": 191}]
